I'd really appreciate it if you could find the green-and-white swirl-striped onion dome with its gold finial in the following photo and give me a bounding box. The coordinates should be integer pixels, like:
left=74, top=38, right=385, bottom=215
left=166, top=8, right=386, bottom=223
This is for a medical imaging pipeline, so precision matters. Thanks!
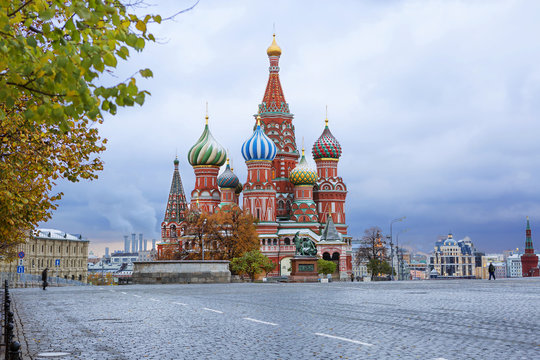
left=188, top=115, right=227, bottom=166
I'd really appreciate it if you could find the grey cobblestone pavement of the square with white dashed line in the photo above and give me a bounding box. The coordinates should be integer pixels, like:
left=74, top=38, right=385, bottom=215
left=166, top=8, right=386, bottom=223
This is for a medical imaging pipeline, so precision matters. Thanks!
left=12, top=279, right=540, bottom=360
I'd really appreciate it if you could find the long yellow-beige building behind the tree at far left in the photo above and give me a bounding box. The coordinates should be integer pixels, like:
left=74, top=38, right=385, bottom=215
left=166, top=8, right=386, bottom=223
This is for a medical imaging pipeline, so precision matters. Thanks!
left=0, top=229, right=89, bottom=282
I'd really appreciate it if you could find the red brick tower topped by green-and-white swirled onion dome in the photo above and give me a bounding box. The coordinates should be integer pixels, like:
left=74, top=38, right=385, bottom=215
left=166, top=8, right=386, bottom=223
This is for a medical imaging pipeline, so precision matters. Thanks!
left=188, top=114, right=227, bottom=213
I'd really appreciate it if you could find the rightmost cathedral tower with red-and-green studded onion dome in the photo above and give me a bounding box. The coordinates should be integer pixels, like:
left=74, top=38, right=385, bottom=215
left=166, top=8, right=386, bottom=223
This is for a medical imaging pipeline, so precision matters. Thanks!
left=312, top=115, right=347, bottom=234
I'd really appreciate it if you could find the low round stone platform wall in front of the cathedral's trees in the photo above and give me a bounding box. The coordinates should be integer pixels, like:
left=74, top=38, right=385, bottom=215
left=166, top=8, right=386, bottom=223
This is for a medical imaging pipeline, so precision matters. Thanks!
left=132, top=260, right=231, bottom=284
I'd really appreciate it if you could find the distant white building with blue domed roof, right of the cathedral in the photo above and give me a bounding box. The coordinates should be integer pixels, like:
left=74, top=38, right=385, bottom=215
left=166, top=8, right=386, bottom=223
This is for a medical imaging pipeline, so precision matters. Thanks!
left=430, top=234, right=475, bottom=278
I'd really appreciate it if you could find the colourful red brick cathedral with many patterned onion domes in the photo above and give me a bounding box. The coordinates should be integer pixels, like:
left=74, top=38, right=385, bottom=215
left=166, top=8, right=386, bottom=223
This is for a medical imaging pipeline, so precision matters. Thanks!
left=158, top=35, right=352, bottom=279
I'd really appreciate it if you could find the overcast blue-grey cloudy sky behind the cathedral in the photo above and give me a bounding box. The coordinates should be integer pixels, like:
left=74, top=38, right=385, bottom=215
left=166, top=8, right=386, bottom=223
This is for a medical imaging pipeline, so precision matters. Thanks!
left=42, top=0, right=540, bottom=253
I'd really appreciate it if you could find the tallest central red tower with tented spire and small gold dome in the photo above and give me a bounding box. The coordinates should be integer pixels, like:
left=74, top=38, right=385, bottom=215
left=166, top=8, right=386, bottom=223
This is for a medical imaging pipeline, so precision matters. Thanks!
left=258, top=34, right=299, bottom=219
